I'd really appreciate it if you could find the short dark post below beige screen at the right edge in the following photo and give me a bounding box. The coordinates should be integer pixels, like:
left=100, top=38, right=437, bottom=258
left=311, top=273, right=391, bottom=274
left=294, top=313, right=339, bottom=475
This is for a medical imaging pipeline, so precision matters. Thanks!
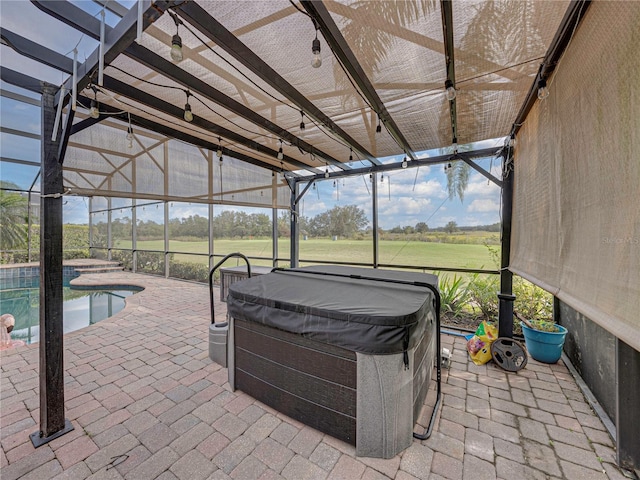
left=616, top=339, right=640, bottom=473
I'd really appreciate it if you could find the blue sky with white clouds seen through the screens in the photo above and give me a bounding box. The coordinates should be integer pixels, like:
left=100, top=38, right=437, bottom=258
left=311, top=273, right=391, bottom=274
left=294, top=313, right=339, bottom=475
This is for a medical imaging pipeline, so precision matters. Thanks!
left=0, top=0, right=502, bottom=229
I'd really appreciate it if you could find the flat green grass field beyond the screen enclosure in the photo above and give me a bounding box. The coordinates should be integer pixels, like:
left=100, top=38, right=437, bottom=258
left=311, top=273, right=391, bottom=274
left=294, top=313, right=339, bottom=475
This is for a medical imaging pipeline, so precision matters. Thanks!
left=116, top=239, right=497, bottom=270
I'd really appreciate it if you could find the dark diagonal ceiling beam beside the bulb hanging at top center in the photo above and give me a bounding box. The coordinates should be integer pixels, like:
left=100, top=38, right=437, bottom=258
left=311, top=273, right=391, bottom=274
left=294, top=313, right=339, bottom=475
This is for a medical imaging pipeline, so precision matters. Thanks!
left=300, top=0, right=416, bottom=165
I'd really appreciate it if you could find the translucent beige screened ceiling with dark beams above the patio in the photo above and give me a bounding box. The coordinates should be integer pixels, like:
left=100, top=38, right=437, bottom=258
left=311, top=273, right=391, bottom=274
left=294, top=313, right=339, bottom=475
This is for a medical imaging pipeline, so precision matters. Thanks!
left=2, top=0, right=581, bottom=200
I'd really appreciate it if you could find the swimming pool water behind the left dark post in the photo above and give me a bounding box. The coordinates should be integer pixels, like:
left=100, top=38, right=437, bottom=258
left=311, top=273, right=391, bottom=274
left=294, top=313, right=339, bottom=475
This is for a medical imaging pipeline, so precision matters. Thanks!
left=0, top=277, right=140, bottom=343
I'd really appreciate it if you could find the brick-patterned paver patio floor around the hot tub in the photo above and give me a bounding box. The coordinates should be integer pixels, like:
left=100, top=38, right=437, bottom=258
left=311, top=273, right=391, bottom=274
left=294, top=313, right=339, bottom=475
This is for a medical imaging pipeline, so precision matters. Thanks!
left=0, top=272, right=625, bottom=480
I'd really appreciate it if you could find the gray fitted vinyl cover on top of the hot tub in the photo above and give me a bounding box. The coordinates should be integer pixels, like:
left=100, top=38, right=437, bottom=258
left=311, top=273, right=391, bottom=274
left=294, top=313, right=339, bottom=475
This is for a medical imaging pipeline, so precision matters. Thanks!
left=227, top=266, right=437, bottom=355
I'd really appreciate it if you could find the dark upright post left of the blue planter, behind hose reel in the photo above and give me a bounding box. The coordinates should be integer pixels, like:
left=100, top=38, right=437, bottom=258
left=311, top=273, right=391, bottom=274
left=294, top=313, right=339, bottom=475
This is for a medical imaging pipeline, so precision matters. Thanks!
left=498, top=148, right=516, bottom=338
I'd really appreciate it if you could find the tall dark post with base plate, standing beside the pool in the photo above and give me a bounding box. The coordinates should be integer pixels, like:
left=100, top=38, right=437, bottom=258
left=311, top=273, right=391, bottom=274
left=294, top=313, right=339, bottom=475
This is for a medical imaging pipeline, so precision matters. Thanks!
left=30, top=84, right=73, bottom=447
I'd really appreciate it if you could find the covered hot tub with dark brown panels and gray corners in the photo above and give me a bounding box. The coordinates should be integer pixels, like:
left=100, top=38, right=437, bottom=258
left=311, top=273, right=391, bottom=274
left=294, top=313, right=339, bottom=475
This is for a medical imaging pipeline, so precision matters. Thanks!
left=227, top=266, right=438, bottom=458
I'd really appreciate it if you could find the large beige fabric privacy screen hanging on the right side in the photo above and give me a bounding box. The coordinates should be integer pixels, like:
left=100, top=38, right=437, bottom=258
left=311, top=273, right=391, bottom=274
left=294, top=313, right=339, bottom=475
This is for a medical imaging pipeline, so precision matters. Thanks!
left=511, top=2, right=640, bottom=350
